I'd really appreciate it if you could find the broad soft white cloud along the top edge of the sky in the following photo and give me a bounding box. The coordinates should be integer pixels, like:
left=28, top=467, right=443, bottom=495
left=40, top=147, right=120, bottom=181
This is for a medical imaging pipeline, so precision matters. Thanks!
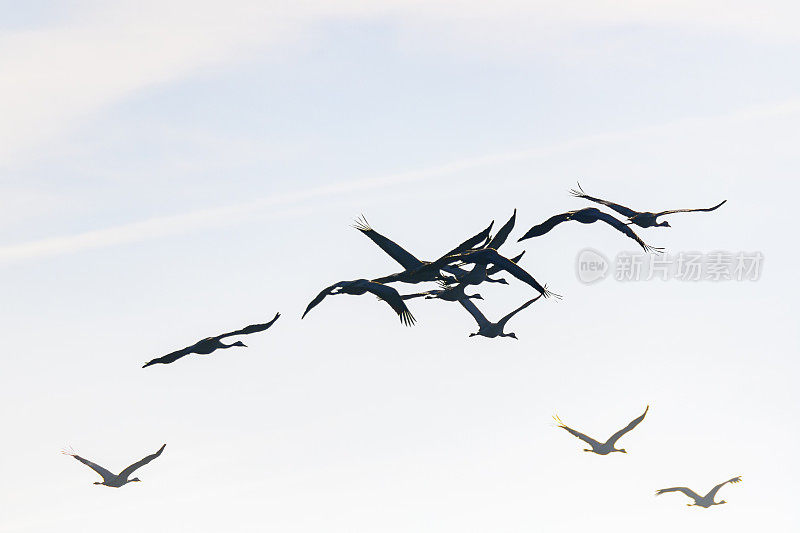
left=0, top=0, right=800, bottom=163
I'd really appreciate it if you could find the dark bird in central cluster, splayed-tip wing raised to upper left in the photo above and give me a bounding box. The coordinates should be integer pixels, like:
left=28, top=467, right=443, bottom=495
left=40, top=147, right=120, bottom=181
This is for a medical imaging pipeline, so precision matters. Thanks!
left=353, top=215, right=494, bottom=283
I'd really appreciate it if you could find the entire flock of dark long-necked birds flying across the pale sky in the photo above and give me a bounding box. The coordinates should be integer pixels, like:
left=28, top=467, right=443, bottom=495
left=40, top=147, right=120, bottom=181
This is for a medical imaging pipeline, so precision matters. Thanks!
left=62, top=184, right=741, bottom=508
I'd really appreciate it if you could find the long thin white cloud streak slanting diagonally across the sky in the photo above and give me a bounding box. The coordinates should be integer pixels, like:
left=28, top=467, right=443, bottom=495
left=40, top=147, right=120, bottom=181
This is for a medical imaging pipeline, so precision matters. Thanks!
left=0, top=96, right=800, bottom=263
